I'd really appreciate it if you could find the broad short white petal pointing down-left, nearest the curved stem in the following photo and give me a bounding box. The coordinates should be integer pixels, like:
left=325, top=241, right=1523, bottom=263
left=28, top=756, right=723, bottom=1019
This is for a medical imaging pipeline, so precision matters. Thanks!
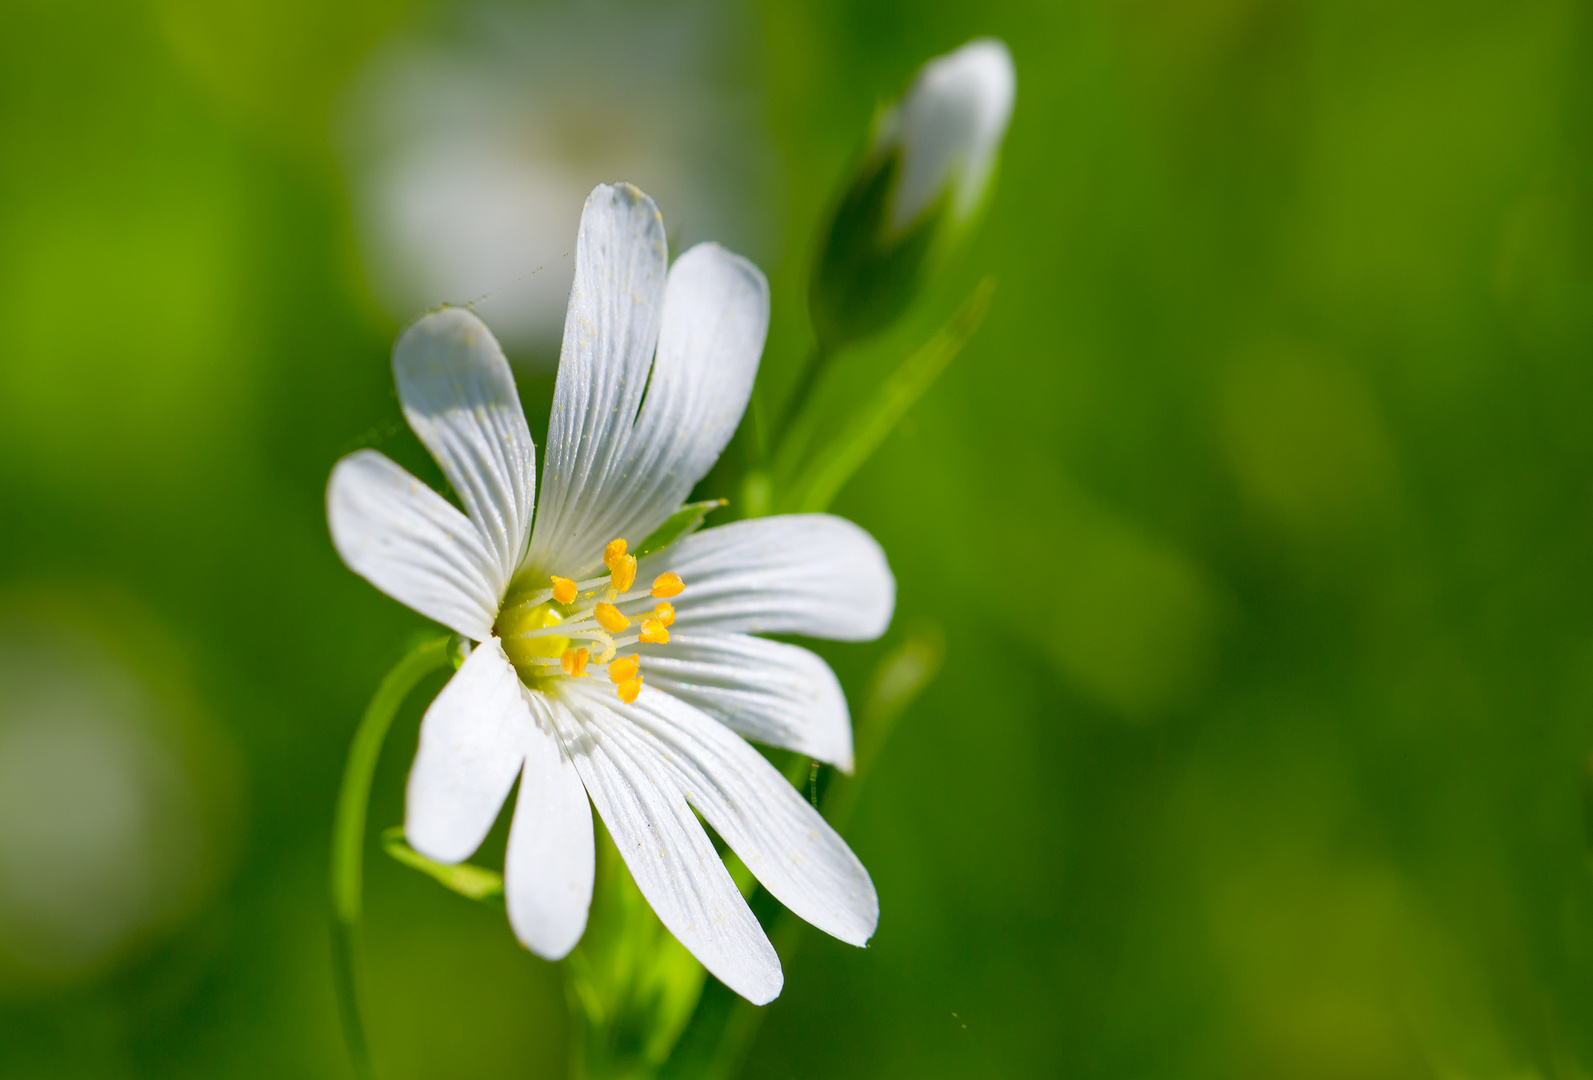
left=403, top=636, right=530, bottom=863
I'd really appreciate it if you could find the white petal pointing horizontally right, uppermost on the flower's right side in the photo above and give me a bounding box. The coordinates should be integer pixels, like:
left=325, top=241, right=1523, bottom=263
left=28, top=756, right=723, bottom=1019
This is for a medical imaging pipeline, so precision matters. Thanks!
left=640, top=515, right=895, bottom=642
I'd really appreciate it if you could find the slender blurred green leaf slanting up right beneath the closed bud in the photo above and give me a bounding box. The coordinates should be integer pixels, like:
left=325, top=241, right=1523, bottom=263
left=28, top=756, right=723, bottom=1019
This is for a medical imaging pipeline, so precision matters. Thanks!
left=777, top=277, right=996, bottom=513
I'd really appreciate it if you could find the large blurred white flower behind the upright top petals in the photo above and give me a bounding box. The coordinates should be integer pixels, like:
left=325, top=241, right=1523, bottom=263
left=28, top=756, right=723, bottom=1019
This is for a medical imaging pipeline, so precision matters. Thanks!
left=346, top=3, right=768, bottom=366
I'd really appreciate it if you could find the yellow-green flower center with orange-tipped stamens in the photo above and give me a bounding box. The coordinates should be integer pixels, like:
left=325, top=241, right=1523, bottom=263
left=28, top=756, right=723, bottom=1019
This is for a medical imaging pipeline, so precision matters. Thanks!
left=492, top=540, right=685, bottom=702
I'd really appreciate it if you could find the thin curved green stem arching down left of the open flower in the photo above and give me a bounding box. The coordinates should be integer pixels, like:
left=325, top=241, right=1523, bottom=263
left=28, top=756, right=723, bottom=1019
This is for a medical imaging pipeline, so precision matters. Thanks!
left=331, top=637, right=449, bottom=1080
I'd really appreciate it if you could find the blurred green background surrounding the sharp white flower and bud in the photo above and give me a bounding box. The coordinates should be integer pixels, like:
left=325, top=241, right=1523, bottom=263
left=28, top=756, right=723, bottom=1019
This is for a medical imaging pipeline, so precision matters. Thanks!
left=0, top=0, right=1593, bottom=1080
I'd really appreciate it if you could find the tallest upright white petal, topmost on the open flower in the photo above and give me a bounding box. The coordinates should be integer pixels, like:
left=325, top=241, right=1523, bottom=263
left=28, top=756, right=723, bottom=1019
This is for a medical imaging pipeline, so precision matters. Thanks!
left=527, top=183, right=669, bottom=573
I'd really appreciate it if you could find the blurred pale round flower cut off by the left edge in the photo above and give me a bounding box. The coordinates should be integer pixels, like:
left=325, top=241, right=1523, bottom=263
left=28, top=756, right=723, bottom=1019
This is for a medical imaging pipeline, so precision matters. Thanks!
left=0, top=608, right=221, bottom=978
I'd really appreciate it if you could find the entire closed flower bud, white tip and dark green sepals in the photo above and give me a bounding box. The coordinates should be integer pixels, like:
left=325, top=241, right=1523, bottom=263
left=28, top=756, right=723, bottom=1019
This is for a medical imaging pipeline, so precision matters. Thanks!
left=809, top=38, right=1016, bottom=347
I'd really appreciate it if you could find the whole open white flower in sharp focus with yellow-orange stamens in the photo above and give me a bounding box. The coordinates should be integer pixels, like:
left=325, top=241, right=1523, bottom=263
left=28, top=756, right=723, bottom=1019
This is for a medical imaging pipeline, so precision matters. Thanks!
left=327, top=185, right=895, bottom=1004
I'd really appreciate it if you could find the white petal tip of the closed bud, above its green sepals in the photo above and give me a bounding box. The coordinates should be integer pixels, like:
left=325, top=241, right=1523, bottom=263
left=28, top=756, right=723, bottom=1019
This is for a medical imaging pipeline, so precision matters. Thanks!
left=875, top=38, right=1018, bottom=231
